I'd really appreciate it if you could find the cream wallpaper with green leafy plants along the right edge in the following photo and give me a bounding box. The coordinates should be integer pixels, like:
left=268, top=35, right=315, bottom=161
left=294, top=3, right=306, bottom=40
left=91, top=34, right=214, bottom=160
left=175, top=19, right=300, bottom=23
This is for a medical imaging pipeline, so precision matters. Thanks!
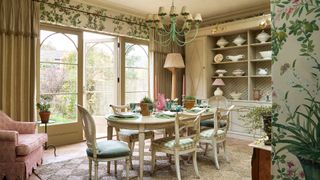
left=271, top=0, right=320, bottom=180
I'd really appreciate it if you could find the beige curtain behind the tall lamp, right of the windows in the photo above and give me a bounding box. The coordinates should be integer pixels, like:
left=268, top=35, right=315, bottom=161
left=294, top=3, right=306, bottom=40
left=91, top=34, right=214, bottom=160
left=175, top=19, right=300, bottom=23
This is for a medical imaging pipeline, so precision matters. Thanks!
left=150, top=34, right=185, bottom=101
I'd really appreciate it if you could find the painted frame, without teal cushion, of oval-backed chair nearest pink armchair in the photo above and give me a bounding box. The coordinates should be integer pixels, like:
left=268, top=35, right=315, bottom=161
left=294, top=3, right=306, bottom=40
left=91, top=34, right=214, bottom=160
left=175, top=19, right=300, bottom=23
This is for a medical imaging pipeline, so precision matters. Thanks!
left=77, top=105, right=129, bottom=180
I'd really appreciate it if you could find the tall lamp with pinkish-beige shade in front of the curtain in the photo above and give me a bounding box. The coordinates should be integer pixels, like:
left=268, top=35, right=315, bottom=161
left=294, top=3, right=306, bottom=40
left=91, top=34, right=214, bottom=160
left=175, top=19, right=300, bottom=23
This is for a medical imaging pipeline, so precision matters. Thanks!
left=163, top=53, right=185, bottom=99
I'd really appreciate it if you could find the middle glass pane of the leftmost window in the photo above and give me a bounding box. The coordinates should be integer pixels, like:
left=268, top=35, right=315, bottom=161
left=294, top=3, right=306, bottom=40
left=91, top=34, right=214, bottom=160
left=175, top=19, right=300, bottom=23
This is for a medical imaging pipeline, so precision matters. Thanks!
left=40, top=63, right=77, bottom=94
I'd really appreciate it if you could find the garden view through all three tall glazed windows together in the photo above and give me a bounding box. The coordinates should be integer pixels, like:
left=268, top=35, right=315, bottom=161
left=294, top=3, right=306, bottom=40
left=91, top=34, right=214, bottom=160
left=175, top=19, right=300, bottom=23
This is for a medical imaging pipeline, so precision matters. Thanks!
left=39, top=30, right=150, bottom=131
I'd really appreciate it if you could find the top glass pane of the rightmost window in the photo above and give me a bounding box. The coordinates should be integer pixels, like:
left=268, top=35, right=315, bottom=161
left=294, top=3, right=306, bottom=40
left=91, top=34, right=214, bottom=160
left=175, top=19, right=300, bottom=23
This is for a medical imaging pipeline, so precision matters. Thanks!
left=126, top=43, right=148, bottom=68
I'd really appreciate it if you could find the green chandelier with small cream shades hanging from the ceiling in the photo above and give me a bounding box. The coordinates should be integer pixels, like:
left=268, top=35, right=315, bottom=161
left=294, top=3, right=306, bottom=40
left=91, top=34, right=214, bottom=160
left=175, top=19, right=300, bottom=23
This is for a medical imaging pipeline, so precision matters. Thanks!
left=146, top=0, right=202, bottom=46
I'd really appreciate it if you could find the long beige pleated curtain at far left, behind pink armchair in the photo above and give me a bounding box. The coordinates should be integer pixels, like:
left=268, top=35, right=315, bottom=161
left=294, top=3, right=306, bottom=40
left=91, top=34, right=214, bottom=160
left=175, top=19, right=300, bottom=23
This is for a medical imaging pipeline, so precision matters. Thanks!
left=0, top=0, right=39, bottom=121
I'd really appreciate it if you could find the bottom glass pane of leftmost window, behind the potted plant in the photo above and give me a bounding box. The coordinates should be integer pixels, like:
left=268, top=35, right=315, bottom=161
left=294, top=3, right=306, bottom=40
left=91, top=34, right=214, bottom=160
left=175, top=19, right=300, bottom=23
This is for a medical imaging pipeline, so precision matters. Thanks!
left=40, top=94, right=77, bottom=123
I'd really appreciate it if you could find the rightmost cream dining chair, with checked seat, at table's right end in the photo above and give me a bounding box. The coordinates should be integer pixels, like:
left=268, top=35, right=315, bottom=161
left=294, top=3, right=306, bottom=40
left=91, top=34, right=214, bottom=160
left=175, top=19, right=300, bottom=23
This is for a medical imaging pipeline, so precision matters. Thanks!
left=199, top=105, right=235, bottom=169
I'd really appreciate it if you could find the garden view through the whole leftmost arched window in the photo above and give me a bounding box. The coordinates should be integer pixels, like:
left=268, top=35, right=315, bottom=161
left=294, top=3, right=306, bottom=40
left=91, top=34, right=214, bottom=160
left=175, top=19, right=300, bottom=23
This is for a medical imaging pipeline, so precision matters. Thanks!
left=39, top=30, right=78, bottom=123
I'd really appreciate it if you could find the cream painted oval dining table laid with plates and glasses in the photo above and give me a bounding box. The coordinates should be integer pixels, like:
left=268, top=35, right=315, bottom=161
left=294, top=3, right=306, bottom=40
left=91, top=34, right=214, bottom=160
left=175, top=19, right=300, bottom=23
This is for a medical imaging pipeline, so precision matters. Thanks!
left=106, top=111, right=214, bottom=179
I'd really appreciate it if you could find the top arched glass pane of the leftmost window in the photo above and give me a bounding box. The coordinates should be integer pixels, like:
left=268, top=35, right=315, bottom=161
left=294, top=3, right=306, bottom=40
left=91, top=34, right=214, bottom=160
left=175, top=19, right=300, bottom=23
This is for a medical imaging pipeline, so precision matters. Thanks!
left=40, top=31, right=78, bottom=63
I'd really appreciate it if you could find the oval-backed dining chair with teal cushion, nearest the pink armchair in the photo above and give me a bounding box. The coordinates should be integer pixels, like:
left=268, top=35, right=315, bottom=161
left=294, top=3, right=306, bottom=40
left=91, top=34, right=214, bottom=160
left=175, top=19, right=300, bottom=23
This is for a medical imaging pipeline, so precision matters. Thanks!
left=77, top=105, right=130, bottom=180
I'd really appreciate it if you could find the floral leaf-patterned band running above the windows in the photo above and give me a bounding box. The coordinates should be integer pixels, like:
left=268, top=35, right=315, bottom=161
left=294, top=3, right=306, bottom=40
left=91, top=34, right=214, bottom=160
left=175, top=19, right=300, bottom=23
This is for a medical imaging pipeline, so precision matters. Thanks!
left=39, top=0, right=149, bottom=39
